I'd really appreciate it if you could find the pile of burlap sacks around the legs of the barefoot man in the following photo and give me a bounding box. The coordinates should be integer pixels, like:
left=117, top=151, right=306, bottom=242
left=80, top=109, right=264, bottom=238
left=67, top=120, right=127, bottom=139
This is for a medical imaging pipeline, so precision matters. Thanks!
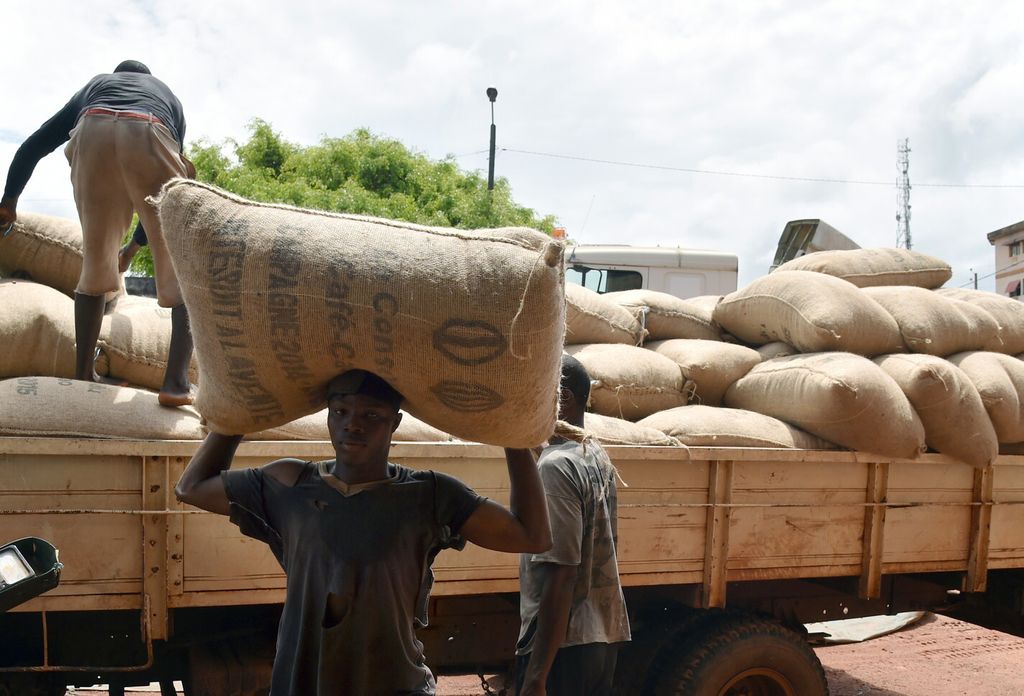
left=0, top=213, right=203, bottom=439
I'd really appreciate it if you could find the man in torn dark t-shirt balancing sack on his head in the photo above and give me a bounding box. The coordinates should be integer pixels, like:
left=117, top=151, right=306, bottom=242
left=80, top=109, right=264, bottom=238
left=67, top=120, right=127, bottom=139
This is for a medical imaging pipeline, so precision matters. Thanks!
left=175, top=369, right=551, bottom=696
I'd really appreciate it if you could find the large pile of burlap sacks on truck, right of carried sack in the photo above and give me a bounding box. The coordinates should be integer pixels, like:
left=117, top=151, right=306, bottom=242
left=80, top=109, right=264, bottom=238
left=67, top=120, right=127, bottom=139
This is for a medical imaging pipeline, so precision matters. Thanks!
left=565, top=249, right=1024, bottom=467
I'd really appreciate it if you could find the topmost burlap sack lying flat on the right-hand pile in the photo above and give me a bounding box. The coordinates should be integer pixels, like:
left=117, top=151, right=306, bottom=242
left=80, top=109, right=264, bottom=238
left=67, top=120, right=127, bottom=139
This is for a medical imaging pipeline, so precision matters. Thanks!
left=775, top=249, right=952, bottom=289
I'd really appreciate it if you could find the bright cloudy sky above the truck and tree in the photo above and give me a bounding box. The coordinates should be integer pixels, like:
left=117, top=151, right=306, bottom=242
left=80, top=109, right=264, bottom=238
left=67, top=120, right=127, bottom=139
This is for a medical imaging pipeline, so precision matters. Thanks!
left=6, top=0, right=1024, bottom=290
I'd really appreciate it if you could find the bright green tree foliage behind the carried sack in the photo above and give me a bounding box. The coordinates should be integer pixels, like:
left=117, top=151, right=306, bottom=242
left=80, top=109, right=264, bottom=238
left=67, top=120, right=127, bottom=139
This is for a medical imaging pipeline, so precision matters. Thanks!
left=132, top=119, right=555, bottom=273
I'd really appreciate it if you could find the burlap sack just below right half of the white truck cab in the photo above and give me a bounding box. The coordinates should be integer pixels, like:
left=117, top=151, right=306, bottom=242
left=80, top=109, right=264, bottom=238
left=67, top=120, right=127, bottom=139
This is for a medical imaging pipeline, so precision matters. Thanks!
left=603, top=290, right=721, bottom=341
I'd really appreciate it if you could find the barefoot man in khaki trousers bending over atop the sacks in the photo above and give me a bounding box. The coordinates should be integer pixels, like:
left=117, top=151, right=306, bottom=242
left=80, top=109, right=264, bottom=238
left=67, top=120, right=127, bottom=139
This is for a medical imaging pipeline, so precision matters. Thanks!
left=0, top=60, right=196, bottom=406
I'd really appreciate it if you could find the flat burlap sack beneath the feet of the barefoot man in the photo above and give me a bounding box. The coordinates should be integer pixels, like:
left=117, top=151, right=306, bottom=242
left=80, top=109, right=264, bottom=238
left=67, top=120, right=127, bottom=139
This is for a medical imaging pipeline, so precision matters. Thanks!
left=0, top=377, right=206, bottom=440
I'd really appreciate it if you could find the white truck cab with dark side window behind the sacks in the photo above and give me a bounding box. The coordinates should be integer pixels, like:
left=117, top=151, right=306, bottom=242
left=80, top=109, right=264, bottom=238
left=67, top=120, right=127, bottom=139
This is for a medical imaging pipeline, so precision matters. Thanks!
left=565, top=245, right=739, bottom=299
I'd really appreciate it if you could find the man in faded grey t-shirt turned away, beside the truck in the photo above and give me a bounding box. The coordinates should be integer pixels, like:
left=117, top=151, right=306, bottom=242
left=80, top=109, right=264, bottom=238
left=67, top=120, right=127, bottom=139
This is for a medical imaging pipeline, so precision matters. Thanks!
left=516, top=355, right=630, bottom=696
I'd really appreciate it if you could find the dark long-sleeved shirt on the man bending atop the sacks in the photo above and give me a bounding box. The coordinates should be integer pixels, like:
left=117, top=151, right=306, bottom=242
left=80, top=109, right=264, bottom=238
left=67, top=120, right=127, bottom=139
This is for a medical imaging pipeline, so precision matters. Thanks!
left=4, top=73, right=185, bottom=198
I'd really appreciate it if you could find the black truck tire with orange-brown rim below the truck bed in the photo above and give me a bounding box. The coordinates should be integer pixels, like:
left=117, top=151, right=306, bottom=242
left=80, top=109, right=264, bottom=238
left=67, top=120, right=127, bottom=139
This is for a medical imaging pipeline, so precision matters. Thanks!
left=651, top=615, right=828, bottom=696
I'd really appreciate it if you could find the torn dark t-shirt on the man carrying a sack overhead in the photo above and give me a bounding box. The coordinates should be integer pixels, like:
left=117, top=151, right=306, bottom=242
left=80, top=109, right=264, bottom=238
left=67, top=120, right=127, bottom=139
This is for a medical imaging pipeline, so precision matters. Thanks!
left=221, top=463, right=484, bottom=696
